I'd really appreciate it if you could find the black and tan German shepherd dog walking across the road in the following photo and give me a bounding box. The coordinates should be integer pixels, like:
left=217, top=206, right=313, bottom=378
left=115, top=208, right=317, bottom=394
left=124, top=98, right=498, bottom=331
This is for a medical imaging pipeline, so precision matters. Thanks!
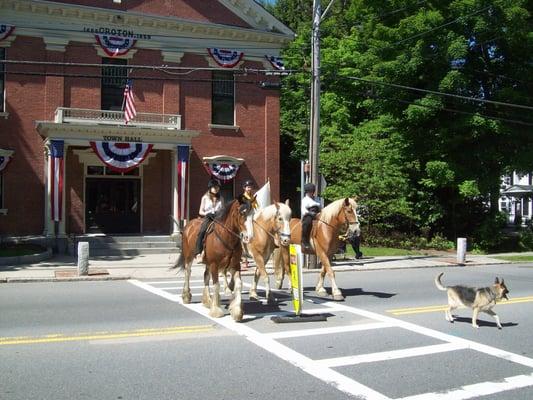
left=435, top=272, right=509, bottom=329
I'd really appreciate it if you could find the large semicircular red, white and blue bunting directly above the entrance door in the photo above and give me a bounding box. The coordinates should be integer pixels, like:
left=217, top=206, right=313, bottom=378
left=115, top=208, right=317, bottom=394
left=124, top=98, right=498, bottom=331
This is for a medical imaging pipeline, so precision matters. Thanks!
left=90, top=142, right=154, bottom=172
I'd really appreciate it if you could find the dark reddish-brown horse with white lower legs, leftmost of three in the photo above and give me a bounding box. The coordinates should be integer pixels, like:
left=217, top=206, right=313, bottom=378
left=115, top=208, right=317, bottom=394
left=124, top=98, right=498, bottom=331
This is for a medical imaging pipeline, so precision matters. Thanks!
left=175, top=198, right=254, bottom=321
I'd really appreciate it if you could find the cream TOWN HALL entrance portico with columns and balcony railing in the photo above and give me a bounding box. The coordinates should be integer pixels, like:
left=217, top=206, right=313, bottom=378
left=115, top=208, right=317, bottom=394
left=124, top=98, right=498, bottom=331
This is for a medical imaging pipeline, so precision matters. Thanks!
left=36, top=107, right=199, bottom=244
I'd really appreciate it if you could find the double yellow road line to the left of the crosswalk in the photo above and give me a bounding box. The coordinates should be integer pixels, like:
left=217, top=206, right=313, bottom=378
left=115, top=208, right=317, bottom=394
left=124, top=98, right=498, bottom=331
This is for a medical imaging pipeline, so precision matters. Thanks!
left=0, top=325, right=215, bottom=346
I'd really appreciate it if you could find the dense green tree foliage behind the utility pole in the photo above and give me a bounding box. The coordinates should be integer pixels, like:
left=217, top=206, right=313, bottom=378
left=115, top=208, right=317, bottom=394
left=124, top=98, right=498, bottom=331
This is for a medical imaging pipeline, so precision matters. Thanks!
left=273, top=0, right=533, bottom=248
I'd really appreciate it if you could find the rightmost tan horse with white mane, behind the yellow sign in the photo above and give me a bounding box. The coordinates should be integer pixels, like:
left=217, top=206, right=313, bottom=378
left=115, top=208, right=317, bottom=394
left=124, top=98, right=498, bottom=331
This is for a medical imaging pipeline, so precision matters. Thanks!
left=274, top=197, right=360, bottom=300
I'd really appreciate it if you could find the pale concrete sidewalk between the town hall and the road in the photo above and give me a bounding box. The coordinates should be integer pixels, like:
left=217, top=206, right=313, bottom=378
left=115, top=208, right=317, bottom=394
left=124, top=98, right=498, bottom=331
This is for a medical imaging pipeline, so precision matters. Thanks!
left=0, top=253, right=512, bottom=283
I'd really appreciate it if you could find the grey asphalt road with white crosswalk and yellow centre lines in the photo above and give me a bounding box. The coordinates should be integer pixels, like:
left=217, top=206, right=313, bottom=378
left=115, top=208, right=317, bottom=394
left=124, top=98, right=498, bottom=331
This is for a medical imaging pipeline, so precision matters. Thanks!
left=0, top=264, right=533, bottom=400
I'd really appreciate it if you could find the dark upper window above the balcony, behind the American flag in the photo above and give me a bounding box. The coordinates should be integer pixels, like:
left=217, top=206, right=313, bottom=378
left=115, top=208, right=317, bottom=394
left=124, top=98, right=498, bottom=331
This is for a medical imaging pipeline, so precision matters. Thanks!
left=101, top=58, right=128, bottom=111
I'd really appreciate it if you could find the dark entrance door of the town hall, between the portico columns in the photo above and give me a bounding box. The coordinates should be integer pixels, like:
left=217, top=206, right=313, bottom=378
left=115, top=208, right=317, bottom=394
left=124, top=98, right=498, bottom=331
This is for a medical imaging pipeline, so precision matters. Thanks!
left=85, top=178, right=141, bottom=233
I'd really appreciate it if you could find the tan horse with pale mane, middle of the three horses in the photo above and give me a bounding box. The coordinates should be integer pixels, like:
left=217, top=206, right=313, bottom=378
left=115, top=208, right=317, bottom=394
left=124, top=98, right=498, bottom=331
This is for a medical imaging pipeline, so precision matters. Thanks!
left=248, top=203, right=292, bottom=303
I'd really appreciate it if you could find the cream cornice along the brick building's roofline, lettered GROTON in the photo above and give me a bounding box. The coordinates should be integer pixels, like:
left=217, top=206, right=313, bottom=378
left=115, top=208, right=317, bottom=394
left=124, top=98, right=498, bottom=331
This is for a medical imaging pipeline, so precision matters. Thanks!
left=0, top=0, right=294, bottom=54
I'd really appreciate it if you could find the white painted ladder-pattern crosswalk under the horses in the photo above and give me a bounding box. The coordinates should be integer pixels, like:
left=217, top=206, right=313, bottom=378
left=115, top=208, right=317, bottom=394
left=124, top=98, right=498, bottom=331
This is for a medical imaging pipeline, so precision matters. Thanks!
left=130, top=280, right=533, bottom=400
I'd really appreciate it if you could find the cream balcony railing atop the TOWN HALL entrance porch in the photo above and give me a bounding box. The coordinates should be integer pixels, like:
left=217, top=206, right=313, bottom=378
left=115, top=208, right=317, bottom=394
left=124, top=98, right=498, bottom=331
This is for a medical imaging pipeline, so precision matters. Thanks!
left=55, top=107, right=181, bottom=129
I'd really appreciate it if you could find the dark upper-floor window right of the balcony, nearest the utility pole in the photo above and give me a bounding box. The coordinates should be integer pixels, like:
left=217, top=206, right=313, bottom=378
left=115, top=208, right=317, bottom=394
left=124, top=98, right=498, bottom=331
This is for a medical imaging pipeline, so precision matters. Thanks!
left=211, top=71, right=235, bottom=125
